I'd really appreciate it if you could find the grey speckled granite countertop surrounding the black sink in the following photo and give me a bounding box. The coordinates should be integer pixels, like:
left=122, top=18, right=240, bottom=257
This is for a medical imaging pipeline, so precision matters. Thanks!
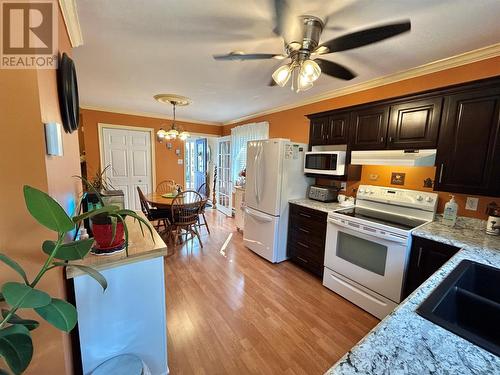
left=327, top=219, right=500, bottom=375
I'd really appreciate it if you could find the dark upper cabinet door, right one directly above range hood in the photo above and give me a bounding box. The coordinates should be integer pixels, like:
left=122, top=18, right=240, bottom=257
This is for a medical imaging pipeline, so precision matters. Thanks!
left=387, top=98, right=443, bottom=149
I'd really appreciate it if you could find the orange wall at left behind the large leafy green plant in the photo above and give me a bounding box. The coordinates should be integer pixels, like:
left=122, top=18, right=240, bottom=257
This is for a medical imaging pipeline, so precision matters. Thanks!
left=0, top=4, right=77, bottom=374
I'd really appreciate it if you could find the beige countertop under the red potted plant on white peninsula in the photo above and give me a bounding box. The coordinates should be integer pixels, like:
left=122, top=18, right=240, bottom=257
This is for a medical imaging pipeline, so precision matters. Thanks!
left=66, top=211, right=167, bottom=279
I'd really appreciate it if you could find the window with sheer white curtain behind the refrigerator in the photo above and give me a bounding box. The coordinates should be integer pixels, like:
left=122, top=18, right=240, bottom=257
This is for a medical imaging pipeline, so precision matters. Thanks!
left=231, top=122, right=269, bottom=183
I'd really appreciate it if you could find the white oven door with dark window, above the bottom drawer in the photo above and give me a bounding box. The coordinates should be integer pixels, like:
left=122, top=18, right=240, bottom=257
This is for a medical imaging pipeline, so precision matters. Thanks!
left=325, top=218, right=408, bottom=303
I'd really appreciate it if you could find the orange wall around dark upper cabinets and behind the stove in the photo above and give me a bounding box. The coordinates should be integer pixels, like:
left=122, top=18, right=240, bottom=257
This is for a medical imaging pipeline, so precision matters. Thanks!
left=223, top=57, right=500, bottom=218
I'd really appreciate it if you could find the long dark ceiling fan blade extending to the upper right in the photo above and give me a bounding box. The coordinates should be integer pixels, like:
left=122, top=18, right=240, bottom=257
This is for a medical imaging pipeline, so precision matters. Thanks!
left=318, top=20, right=411, bottom=54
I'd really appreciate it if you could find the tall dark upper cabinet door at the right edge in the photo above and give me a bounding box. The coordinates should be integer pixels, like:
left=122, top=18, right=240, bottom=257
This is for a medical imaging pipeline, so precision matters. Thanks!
left=435, top=88, right=500, bottom=196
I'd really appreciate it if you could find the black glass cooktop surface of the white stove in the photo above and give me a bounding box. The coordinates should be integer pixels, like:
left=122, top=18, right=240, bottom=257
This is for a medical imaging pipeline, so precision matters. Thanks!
left=335, top=207, right=427, bottom=230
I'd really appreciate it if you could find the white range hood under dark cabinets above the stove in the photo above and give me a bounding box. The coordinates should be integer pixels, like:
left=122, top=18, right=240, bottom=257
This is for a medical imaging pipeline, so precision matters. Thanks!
left=351, top=149, right=436, bottom=167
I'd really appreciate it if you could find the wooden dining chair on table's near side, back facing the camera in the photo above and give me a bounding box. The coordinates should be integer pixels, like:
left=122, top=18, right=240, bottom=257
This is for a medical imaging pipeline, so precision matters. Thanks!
left=170, top=190, right=203, bottom=248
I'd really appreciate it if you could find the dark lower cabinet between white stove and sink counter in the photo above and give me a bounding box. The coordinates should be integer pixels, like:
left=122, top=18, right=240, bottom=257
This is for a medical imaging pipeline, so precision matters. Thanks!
left=403, top=237, right=459, bottom=298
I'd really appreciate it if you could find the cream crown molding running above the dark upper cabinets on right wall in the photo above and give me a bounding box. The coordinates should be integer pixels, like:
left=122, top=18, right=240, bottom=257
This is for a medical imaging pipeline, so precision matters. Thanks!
left=223, top=43, right=500, bottom=125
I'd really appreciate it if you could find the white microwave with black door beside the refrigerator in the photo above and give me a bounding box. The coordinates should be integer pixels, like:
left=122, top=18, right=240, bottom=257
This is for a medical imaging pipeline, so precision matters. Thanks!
left=304, top=151, right=346, bottom=176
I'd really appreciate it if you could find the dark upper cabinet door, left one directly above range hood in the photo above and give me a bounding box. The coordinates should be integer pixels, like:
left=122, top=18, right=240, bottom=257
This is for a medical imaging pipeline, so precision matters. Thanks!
left=351, top=106, right=389, bottom=150
